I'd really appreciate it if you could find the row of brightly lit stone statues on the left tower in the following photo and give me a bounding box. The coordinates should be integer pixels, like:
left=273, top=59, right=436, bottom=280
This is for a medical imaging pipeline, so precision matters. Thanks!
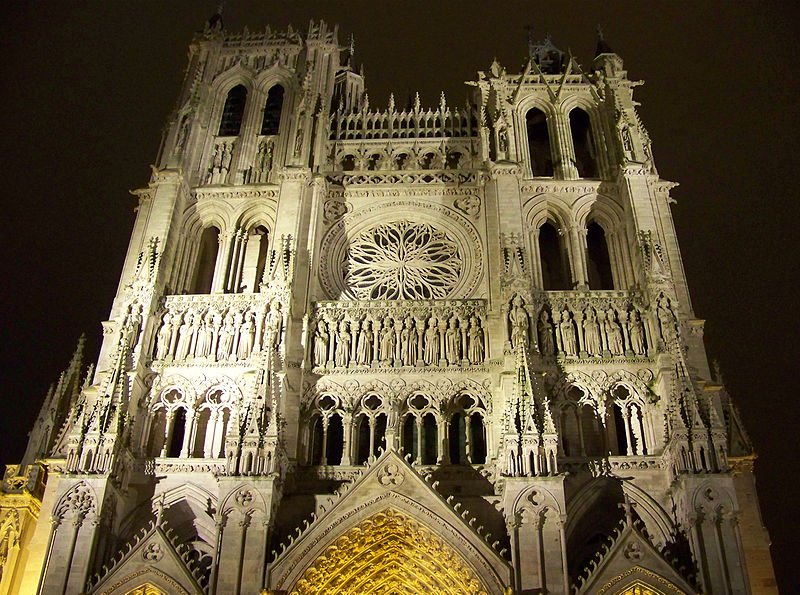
left=154, top=301, right=283, bottom=362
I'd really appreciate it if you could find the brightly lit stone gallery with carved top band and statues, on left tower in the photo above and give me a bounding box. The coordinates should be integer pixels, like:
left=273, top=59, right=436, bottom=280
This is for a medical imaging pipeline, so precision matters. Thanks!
left=153, top=293, right=283, bottom=364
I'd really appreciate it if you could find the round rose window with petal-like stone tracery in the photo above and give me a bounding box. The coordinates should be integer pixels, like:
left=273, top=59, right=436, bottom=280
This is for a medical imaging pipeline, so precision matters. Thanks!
left=341, top=221, right=464, bottom=300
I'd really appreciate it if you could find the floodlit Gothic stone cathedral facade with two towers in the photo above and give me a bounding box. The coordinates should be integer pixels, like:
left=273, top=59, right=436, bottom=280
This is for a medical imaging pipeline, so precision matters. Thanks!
left=0, top=15, right=777, bottom=595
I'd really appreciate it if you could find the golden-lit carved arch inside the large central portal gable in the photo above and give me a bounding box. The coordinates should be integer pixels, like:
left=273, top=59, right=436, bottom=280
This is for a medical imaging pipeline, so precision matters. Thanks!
left=291, top=509, right=488, bottom=595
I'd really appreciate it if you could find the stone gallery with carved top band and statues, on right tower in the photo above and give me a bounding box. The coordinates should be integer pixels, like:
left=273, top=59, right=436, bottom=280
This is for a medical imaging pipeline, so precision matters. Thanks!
left=528, top=291, right=656, bottom=358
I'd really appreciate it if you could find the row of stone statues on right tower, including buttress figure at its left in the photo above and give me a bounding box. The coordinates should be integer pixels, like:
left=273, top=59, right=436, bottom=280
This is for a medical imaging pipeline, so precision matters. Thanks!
left=508, top=296, right=652, bottom=357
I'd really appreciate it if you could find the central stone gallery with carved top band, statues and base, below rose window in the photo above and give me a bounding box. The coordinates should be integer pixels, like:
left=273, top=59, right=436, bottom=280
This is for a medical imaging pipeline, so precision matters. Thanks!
left=311, top=300, right=487, bottom=372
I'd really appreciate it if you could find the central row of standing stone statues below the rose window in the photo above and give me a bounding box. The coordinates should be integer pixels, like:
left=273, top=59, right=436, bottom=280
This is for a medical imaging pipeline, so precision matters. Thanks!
left=313, top=313, right=486, bottom=368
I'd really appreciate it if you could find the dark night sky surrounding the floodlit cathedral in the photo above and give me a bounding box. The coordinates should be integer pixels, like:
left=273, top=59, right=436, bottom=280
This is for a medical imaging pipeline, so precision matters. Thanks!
left=0, top=0, right=800, bottom=593
